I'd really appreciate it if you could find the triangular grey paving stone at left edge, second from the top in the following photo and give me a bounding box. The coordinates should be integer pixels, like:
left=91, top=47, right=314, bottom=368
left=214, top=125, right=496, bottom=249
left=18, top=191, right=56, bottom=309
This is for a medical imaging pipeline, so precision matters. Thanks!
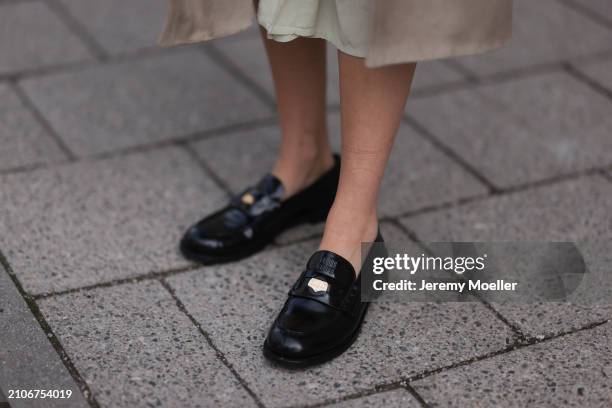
left=0, top=84, right=66, bottom=170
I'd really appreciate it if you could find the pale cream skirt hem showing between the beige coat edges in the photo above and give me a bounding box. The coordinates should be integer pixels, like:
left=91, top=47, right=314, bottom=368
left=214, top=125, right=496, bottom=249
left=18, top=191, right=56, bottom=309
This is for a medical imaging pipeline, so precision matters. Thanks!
left=257, top=0, right=374, bottom=57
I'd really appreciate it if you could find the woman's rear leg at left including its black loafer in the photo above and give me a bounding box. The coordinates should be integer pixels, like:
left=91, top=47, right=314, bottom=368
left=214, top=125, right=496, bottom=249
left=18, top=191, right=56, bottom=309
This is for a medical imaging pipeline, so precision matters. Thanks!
left=180, top=33, right=340, bottom=265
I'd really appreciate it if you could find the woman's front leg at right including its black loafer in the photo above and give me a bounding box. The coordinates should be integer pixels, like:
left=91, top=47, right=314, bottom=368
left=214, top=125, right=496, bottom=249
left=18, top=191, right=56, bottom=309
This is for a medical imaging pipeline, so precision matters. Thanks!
left=263, top=48, right=415, bottom=367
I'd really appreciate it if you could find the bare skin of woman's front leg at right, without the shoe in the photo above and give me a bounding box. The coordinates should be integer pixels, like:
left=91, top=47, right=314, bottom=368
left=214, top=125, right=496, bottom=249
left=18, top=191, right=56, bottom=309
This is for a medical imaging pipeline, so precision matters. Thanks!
left=320, top=52, right=416, bottom=272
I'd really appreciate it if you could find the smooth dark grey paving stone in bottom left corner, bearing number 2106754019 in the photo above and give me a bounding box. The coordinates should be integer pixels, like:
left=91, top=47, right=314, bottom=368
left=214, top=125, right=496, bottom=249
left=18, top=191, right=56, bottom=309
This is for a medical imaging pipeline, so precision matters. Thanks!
left=0, top=265, right=89, bottom=408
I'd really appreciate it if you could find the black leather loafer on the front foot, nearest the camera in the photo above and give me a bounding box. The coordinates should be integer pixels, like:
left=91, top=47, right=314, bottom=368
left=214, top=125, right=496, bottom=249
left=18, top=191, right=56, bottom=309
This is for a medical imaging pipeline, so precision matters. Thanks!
left=263, top=232, right=386, bottom=368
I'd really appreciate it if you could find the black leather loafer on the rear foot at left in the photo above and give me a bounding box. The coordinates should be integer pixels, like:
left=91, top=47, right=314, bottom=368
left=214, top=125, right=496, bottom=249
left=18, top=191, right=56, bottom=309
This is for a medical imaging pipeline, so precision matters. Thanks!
left=180, top=155, right=340, bottom=265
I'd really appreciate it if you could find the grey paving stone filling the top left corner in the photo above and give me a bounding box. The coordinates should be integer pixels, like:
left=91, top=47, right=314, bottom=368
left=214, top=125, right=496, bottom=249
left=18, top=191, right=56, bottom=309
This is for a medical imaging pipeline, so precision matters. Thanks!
left=0, top=1, right=91, bottom=74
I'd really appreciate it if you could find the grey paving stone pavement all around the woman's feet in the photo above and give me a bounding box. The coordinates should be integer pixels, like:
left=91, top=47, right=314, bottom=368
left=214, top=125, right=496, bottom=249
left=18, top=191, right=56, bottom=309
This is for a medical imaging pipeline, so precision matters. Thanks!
left=0, top=0, right=612, bottom=407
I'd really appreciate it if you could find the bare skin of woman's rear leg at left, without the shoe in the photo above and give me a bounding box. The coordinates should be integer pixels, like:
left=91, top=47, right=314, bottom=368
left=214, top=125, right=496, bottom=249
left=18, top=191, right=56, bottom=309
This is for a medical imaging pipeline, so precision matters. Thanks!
left=261, top=28, right=334, bottom=198
